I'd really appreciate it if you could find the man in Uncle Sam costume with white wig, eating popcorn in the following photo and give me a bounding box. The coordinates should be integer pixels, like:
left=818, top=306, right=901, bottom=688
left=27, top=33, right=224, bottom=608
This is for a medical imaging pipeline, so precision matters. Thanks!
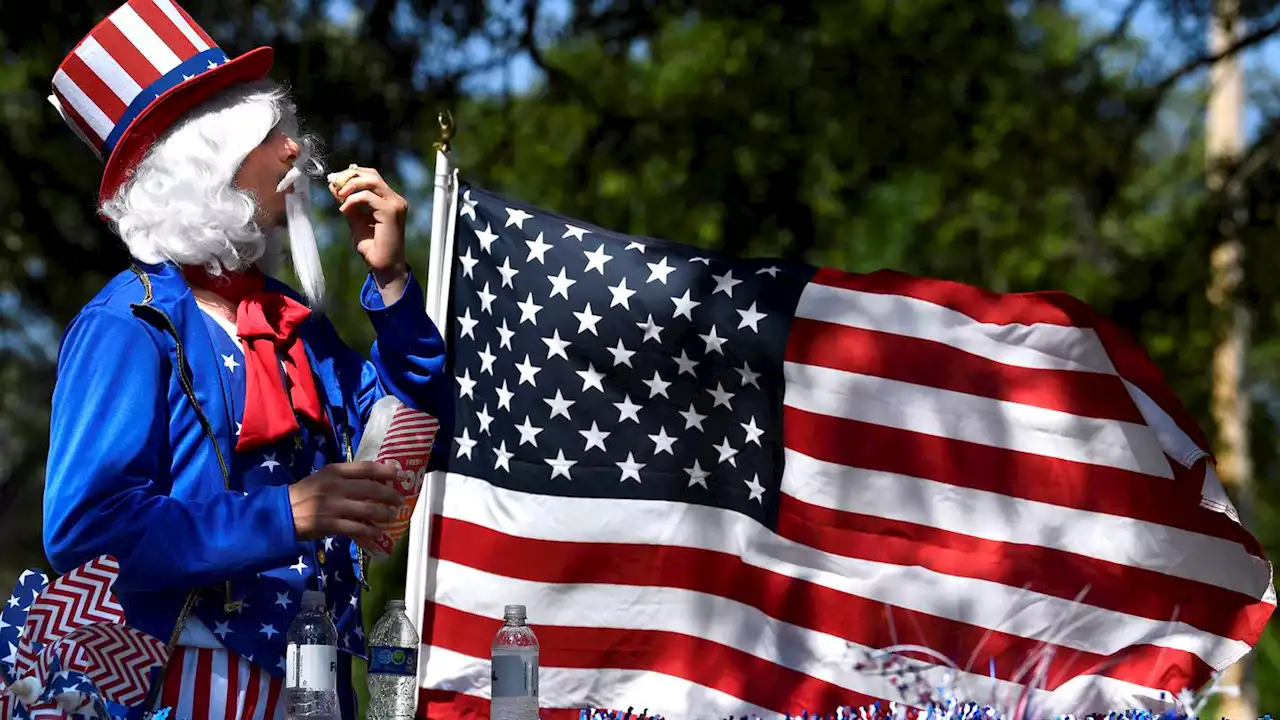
left=45, top=0, right=448, bottom=720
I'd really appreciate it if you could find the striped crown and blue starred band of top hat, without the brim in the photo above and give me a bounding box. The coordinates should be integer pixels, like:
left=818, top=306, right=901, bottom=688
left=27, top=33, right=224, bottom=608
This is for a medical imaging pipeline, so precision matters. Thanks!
left=49, top=0, right=227, bottom=159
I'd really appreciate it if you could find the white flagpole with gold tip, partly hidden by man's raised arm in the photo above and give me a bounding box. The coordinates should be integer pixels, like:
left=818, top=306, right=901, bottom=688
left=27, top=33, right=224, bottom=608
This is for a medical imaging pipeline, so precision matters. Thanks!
left=404, top=110, right=458, bottom=691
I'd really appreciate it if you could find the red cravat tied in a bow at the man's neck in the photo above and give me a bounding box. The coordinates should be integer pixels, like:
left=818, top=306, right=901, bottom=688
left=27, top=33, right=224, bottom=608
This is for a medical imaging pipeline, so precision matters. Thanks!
left=183, top=268, right=325, bottom=452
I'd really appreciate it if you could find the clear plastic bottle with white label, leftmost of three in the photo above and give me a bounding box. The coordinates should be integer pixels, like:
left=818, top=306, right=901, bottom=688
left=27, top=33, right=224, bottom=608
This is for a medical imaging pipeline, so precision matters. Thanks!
left=284, top=591, right=339, bottom=720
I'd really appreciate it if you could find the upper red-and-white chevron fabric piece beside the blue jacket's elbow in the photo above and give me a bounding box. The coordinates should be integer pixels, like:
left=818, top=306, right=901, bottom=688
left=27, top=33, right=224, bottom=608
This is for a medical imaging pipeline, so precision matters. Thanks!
left=17, top=555, right=124, bottom=678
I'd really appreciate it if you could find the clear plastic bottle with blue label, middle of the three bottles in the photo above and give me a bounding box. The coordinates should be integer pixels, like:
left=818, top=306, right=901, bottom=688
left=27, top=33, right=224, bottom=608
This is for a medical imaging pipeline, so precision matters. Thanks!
left=367, top=600, right=419, bottom=720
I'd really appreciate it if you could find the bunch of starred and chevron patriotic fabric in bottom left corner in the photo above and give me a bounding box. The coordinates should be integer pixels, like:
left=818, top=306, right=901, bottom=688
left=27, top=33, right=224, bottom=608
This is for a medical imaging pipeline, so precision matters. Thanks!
left=0, top=555, right=168, bottom=720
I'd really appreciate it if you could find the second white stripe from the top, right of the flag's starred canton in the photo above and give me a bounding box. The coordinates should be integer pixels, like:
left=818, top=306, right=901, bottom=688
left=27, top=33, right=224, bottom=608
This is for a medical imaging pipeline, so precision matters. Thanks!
left=783, top=363, right=1174, bottom=479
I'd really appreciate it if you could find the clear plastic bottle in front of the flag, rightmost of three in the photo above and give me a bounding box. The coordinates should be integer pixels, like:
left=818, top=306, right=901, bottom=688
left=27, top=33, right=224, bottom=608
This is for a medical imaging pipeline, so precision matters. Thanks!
left=489, top=605, right=538, bottom=720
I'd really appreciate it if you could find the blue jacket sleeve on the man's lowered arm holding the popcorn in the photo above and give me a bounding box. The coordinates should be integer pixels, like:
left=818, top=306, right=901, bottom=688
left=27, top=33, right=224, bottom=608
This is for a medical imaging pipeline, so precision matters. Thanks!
left=44, top=306, right=297, bottom=591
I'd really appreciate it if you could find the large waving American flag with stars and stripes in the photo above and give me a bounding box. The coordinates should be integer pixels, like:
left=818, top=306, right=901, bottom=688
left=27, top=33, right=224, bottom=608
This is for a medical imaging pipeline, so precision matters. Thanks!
left=419, top=186, right=1275, bottom=717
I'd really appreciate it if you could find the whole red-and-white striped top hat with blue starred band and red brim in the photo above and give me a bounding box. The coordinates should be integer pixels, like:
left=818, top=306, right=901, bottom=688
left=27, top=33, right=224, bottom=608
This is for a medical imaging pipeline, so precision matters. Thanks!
left=49, top=0, right=274, bottom=202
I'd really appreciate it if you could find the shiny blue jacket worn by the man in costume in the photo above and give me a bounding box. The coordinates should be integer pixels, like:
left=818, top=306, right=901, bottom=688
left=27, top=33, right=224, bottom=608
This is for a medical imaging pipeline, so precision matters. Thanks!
left=44, top=264, right=451, bottom=655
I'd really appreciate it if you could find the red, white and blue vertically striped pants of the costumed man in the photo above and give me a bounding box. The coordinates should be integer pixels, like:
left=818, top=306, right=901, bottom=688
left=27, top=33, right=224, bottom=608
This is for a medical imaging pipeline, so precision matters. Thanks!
left=160, top=647, right=284, bottom=720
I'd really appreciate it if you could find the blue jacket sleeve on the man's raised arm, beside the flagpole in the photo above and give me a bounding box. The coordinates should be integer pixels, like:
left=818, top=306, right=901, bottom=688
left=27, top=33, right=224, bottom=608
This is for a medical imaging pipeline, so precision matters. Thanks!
left=358, top=270, right=453, bottom=421
